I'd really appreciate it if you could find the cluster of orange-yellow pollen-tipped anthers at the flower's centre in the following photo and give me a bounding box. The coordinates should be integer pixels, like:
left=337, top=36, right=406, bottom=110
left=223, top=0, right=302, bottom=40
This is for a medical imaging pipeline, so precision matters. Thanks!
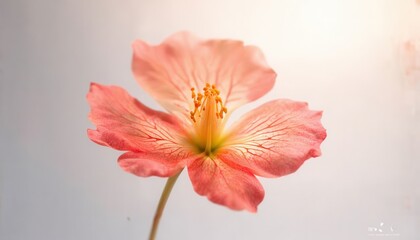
left=190, top=83, right=227, bottom=122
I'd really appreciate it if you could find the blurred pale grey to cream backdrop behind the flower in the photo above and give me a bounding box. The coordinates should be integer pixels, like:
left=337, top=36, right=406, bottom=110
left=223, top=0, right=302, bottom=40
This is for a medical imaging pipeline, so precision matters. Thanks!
left=0, top=0, right=420, bottom=240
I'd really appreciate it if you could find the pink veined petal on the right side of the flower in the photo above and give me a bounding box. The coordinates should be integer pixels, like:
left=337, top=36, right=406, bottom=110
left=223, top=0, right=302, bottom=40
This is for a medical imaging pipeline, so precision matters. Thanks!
left=218, top=99, right=326, bottom=177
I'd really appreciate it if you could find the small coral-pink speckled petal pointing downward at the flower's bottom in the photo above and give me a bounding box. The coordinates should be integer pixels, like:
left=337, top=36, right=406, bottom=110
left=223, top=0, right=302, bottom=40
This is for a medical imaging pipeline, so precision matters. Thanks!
left=188, top=157, right=264, bottom=212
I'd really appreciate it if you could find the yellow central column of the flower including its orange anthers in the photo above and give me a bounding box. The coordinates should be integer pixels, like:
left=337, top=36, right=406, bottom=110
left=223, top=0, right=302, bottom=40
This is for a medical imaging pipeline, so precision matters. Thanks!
left=190, top=83, right=227, bottom=155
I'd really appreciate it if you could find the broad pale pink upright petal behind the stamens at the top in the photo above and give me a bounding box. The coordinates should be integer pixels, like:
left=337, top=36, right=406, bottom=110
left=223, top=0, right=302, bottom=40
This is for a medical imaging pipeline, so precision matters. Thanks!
left=132, top=32, right=276, bottom=119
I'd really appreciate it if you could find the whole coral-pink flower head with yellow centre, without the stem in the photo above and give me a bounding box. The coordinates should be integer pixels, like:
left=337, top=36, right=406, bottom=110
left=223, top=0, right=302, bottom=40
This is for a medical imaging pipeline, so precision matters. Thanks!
left=87, top=32, right=326, bottom=212
